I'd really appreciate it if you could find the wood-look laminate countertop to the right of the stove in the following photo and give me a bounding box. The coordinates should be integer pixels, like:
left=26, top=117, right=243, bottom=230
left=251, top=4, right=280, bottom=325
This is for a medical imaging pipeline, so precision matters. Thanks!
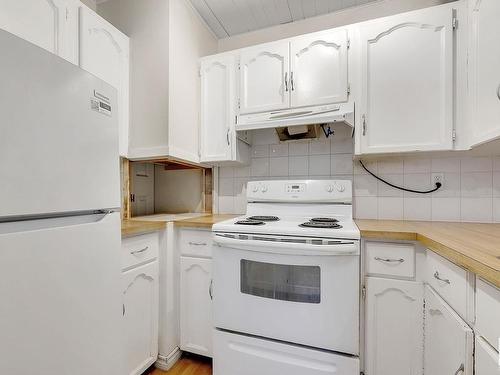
left=356, top=220, right=500, bottom=288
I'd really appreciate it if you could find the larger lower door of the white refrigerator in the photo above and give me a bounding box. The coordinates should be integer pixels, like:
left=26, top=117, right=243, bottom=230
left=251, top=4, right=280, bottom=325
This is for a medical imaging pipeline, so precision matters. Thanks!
left=0, top=213, right=124, bottom=375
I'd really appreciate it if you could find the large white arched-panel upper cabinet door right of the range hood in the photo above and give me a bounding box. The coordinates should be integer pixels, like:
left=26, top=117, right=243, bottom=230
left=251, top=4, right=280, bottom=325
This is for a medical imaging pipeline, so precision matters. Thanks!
left=358, top=5, right=454, bottom=154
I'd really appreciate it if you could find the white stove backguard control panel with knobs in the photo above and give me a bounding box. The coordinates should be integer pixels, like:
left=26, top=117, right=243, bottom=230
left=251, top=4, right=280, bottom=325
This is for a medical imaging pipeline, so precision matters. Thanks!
left=247, top=180, right=352, bottom=204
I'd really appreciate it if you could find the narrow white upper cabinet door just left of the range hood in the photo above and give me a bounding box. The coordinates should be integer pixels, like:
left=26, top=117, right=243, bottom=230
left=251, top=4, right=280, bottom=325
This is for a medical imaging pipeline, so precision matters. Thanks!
left=200, top=55, right=236, bottom=162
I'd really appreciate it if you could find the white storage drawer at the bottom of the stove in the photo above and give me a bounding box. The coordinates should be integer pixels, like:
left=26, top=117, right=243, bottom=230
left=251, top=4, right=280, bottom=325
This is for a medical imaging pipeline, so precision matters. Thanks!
left=214, top=330, right=359, bottom=375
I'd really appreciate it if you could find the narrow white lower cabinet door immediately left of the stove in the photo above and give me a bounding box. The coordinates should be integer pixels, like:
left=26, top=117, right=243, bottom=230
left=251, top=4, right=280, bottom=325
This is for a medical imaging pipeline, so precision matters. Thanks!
left=180, top=256, right=213, bottom=357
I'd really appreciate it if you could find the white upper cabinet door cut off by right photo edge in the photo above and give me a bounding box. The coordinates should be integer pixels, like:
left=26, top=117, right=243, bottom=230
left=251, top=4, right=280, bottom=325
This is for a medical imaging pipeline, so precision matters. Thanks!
left=469, top=0, right=500, bottom=146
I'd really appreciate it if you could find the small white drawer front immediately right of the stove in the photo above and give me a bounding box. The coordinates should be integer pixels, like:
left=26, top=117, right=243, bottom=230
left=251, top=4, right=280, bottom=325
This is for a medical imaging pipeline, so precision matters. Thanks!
left=365, top=242, right=415, bottom=278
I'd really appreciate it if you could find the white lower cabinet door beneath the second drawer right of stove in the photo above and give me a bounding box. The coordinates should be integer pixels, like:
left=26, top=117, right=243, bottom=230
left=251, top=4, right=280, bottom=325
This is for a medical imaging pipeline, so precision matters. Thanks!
left=424, top=286, right=470, bottom=375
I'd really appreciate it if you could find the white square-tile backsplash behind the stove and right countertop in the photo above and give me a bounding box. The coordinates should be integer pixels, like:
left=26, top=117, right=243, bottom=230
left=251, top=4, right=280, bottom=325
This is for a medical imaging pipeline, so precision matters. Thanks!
left=219, top=125, right=500, bottom=222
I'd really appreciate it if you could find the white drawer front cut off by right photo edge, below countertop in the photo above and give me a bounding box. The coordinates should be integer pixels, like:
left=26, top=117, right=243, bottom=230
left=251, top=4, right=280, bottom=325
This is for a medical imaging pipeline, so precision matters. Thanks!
left=476, top=278, right=500, bottom=347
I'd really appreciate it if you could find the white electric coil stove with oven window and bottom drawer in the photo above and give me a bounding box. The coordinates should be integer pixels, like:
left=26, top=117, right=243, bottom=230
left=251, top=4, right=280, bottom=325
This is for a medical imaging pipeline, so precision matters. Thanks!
left=213, top=180, right=360, bottom=375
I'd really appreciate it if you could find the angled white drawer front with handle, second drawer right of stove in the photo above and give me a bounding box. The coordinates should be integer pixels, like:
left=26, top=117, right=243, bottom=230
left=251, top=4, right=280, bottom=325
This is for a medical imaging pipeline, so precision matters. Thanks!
left=425, top=250, right=468, bottom=319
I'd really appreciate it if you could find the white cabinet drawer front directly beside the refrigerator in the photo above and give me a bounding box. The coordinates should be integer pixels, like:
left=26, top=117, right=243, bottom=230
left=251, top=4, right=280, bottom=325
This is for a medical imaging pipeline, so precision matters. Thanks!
left=122, top=233, right=159, bottom=269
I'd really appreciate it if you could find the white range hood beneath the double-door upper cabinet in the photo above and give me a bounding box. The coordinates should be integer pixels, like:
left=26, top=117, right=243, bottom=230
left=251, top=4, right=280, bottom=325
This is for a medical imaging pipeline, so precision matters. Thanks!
left=236, top=103, right=354, bottom=131
